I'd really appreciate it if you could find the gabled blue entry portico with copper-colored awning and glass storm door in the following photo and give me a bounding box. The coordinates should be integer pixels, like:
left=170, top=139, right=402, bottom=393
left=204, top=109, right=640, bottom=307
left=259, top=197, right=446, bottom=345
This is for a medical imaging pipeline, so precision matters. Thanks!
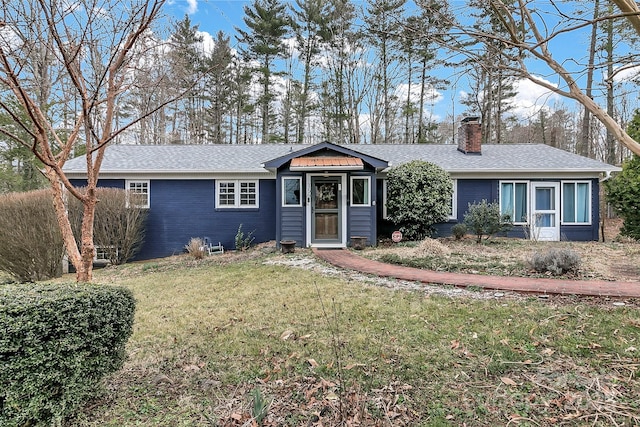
left=264, top=142, right=389, bottom=248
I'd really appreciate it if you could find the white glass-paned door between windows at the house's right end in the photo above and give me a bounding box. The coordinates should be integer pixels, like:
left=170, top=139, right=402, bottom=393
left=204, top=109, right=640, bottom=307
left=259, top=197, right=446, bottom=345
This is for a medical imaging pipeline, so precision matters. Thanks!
left=530, top=182, right=560, bottom=241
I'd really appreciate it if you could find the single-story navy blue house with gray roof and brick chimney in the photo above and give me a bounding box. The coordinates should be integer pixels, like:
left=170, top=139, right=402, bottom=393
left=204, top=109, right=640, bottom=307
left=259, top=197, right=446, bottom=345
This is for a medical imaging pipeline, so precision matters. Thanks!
left=64, top=119, right=620, bottom=259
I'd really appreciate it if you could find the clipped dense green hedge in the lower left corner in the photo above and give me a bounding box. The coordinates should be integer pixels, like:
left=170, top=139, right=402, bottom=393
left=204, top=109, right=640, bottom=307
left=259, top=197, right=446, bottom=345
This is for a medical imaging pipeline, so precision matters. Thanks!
left=0, top=284, right=135, bottom=426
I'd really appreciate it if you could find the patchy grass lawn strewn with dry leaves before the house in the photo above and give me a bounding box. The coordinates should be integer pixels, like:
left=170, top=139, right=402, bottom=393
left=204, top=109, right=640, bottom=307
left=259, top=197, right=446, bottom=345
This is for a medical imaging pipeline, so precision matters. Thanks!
left=72, top=250, right=640, bottom=426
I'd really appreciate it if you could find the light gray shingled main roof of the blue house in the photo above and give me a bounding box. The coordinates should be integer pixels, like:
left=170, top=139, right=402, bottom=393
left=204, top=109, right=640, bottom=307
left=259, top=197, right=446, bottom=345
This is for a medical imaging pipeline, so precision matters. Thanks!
left=64, top=144, right=620, bottom=177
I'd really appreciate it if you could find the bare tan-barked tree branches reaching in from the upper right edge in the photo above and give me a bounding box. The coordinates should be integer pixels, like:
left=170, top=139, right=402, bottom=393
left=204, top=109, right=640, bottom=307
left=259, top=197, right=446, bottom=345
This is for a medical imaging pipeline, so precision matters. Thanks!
left=430, top=0, right=640, bottom=154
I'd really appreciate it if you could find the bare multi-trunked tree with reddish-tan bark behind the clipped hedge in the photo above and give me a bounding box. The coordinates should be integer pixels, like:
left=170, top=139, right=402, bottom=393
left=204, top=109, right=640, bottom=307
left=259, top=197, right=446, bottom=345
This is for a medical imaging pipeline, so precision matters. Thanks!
left=0, top=0, right=170, bottom=282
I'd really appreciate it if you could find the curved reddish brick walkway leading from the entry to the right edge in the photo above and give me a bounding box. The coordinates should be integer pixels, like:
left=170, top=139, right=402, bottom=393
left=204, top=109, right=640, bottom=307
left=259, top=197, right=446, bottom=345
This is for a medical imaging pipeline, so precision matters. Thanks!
left=313, top=248, right=640, bottom=298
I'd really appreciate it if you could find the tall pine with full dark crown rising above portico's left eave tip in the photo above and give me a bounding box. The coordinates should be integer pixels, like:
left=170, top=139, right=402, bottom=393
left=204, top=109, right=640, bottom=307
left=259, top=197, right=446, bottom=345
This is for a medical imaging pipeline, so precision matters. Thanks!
left=236, top=0, right=291, bottom=144
